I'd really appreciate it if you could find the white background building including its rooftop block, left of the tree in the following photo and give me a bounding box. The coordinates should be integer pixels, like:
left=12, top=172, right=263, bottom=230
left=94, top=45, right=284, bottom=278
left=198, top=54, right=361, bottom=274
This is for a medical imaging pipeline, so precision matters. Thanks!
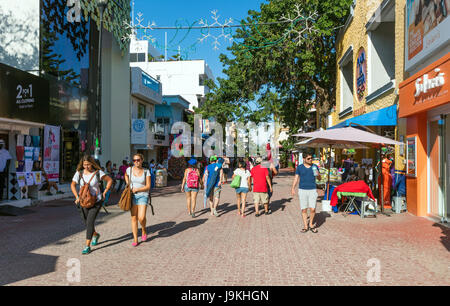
left=130, top=41, right=214, bottom=110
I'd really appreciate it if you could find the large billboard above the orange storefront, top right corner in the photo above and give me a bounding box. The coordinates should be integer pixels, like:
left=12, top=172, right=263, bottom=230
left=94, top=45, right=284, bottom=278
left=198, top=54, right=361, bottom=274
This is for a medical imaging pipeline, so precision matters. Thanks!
left=405, top=0, right=450, bottom=70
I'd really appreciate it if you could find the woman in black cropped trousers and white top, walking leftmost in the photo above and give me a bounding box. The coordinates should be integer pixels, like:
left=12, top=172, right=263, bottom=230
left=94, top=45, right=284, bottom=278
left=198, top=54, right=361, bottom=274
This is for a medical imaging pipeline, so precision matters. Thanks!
left=70, top=155, right=112, bottom=255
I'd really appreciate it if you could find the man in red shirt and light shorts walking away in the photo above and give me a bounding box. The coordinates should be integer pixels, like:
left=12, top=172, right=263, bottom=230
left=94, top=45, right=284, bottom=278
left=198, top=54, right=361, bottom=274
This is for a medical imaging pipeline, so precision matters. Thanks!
left=250, top=157, right=273, bottom=217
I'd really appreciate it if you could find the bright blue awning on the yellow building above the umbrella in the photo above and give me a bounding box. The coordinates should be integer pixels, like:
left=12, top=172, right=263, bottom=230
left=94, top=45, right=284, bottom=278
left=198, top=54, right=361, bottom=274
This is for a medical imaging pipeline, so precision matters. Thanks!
left=329, top=104, right=397, bottom=129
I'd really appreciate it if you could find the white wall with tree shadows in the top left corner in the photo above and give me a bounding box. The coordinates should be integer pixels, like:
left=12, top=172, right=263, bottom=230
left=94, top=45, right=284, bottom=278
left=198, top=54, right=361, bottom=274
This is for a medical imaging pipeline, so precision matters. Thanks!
left=0, top=0, right=40, bottom=71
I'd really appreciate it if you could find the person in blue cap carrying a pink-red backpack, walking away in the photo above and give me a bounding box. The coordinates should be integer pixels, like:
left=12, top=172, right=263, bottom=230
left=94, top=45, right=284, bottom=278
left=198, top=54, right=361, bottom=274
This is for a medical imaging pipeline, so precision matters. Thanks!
left=181, top=158, right=203, bottom=218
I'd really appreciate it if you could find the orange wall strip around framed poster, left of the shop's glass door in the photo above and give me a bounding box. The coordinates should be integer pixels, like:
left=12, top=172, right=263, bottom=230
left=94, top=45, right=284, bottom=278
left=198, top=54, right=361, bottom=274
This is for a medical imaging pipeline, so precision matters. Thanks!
left=406, top=112, right=428, bottom=217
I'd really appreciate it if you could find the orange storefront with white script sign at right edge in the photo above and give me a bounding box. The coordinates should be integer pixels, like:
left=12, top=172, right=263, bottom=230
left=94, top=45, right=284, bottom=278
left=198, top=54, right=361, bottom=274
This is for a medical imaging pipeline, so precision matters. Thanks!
left=399, top=53, right=450, bottom=221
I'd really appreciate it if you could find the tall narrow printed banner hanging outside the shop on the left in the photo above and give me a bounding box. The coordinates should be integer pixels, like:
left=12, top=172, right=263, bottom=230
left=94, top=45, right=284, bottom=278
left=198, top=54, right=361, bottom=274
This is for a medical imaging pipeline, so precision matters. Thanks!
left=43, top=125, right=61, bottom=182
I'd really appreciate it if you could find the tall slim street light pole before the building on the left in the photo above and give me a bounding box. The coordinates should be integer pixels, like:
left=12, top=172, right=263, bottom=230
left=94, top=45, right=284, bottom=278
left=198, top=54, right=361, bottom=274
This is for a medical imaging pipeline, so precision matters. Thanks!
left=94, top=0, right=109, bottom=158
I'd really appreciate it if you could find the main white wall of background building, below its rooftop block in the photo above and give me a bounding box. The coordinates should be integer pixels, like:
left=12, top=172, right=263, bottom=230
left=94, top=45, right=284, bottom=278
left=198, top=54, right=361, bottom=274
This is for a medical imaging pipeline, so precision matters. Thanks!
left=130, top=60, right=214, bottom=110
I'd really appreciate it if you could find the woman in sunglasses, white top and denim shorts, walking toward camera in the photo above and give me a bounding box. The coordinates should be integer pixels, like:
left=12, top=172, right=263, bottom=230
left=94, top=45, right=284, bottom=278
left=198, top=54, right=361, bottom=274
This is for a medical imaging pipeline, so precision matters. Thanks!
left=125, top=154, right=151, bottom=246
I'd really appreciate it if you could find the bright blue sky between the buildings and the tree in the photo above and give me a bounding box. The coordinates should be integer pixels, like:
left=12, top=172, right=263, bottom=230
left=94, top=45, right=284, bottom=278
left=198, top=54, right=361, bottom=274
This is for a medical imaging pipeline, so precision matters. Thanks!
left=131, top=0, right=267, bottom=82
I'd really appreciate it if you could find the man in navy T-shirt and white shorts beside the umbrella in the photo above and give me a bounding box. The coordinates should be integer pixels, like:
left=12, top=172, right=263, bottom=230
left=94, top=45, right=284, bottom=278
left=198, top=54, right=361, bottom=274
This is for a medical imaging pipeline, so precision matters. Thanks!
left=291, top=153, right=320, bottom=233
